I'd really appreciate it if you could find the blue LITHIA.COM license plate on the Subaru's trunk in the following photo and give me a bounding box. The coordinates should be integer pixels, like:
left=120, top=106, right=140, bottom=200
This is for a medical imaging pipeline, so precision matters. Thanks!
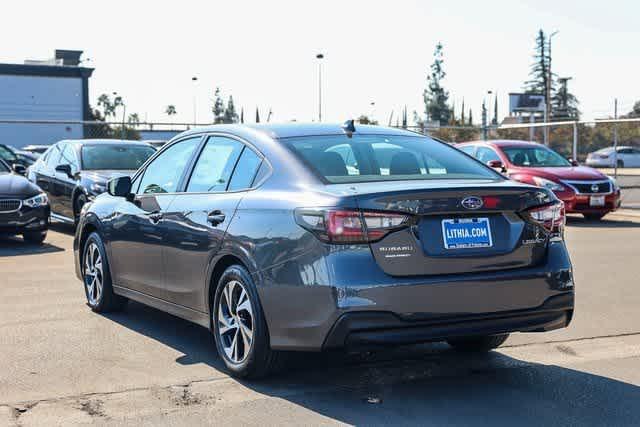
left=442, top=218, right=493, bottom=249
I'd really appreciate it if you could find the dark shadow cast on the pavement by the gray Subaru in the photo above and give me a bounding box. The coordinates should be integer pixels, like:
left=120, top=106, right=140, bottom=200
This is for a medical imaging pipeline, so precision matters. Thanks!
left=101, top=303, right=640, bottom=426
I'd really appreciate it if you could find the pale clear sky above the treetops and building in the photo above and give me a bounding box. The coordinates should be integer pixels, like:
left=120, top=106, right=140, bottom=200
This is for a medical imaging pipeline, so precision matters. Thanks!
left=0, top=0, right=640, bottom=124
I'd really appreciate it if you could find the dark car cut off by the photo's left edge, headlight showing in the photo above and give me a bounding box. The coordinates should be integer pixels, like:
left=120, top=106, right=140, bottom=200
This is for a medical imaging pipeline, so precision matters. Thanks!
left=0, top=160, right=49, bottom=244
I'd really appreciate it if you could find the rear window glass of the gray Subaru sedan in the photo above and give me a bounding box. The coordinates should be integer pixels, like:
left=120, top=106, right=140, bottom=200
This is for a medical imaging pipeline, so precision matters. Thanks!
left=282, top=135, right=501, bottom=184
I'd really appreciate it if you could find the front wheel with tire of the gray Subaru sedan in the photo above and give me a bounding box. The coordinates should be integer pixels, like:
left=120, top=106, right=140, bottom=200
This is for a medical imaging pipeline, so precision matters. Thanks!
left=82, top=232, right=127, bottom=313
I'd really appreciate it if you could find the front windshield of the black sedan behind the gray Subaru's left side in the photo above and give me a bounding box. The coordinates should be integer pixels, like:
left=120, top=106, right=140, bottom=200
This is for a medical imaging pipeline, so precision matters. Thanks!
left=82, top=144, right=155, bottom=170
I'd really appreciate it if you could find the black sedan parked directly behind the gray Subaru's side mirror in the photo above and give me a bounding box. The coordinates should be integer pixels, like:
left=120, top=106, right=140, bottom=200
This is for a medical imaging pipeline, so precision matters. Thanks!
left=28, top=139, right=156, bottom=227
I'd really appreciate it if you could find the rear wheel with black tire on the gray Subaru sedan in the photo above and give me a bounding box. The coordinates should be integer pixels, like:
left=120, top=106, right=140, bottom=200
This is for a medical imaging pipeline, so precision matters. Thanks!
left=211, top=265, right=282, bottom=378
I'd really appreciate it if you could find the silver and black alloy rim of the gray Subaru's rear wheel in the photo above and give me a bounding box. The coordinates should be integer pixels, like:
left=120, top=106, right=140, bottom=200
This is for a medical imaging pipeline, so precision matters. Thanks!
left=217, top=280, right=254, bottom=364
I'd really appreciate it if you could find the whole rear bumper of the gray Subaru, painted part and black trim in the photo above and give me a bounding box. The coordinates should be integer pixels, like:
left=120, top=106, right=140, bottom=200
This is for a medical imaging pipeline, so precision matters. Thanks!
left=258, top=242, right=574, bottom=351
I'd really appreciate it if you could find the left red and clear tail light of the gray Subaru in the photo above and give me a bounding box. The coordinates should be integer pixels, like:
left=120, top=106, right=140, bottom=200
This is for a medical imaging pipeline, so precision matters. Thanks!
left=295, top=209, right=410, bottom=244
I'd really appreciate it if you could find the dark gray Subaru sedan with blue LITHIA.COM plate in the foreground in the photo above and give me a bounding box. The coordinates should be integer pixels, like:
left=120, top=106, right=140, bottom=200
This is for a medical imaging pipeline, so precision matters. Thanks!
left=74, top=121, right=574, bottom=377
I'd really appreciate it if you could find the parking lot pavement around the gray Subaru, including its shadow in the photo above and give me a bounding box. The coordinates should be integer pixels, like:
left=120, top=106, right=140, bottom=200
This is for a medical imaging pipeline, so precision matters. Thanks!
left=0, top=214, right=640, bottom=426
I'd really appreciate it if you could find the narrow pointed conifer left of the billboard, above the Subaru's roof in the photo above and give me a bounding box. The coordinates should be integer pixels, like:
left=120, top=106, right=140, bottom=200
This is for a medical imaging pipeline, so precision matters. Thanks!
left=422, top=43, right=451, bottom=125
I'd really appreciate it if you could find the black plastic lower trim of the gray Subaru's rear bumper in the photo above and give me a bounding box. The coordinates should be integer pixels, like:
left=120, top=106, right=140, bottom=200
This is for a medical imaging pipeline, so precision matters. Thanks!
left=323, top=292, right=574, bottom=349
